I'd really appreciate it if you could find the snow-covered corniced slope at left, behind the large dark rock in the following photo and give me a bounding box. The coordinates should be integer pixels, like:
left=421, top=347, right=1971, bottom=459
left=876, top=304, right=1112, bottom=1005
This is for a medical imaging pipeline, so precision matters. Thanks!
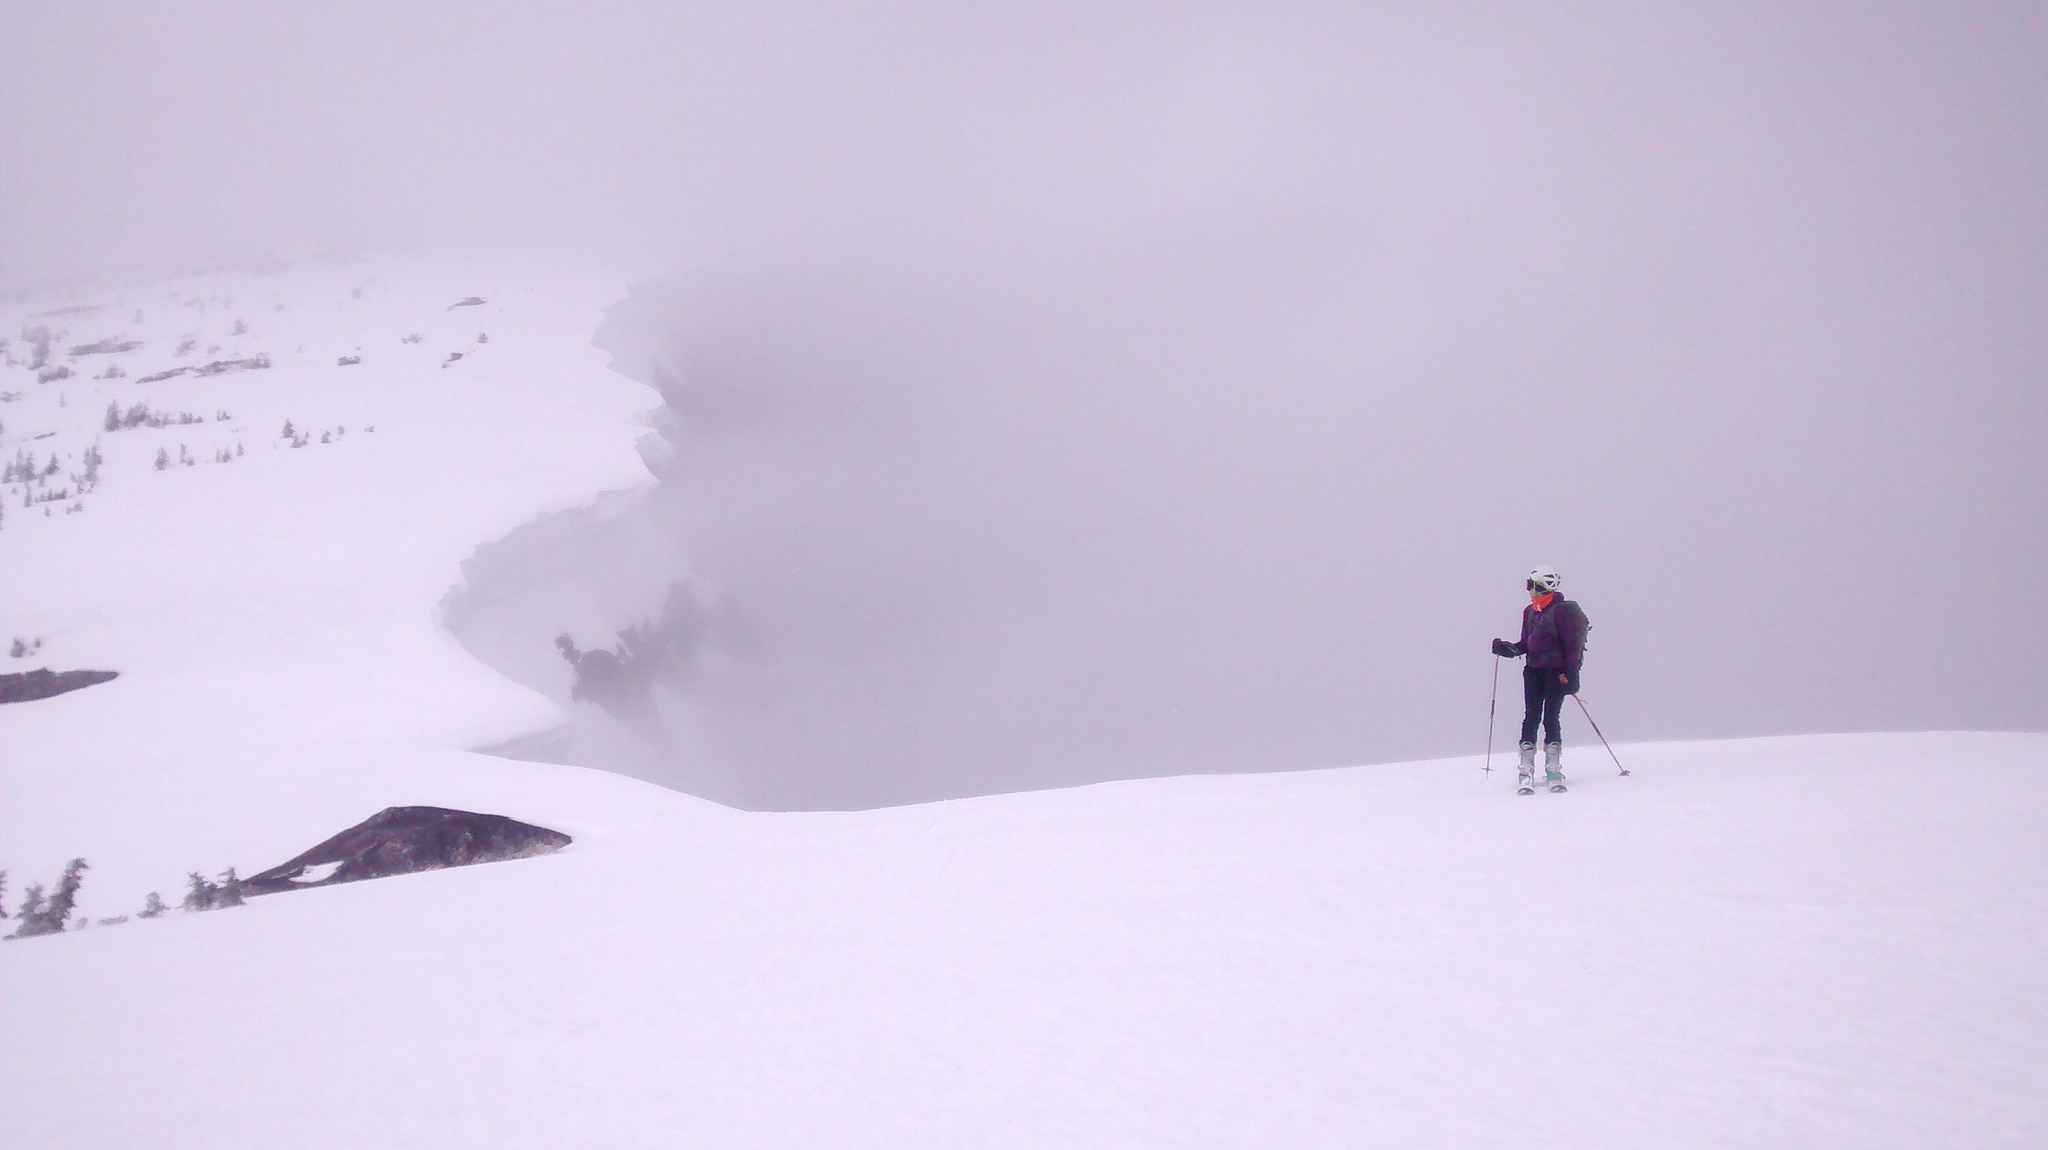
left=0, top=260, right=657, bottom=915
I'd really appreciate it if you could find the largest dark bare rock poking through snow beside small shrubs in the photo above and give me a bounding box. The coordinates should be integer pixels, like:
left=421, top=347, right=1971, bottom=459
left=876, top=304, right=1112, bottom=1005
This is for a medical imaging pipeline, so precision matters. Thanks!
left=242, top=806, right=569, bottom=894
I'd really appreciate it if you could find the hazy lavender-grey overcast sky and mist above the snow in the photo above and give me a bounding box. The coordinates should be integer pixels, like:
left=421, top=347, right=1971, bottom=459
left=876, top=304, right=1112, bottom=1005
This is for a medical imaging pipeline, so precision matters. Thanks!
left=0, top=2, right=2048, bottom=804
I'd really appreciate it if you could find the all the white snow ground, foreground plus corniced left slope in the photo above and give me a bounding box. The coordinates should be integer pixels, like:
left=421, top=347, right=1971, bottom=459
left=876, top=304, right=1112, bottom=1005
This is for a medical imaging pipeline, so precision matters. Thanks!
left=0, top=264, right=2048, bottom=1150
